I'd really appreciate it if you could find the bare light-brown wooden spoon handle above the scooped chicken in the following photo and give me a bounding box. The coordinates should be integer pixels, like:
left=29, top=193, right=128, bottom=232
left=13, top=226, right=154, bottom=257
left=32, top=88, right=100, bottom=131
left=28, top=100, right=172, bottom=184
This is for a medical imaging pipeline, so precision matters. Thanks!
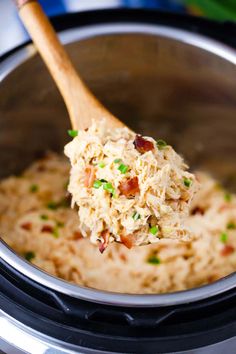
left=16, top=0, right=124, bottom=130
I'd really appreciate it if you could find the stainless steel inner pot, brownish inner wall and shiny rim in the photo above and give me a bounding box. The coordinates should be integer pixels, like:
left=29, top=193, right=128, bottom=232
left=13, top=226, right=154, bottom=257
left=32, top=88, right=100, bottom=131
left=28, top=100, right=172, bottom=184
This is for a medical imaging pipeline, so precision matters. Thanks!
left=0, top=23, right=236, bottom=306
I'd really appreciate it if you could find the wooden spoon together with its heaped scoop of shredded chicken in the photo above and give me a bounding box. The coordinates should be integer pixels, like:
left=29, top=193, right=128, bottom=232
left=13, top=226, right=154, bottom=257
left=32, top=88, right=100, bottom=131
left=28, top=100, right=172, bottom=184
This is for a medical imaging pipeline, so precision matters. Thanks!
left=17, top=0, right=198, bottom=252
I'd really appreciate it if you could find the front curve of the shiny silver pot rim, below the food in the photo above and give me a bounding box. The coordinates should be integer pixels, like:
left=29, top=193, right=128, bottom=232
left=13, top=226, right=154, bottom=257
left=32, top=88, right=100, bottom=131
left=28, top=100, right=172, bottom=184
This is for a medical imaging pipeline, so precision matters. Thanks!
left=0, top=242, right=236, bottom=307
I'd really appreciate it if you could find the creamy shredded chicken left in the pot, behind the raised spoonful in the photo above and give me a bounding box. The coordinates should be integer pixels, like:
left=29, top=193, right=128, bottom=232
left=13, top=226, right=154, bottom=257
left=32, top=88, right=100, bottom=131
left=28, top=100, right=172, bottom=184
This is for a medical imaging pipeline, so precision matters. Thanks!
left=0, top=155, right=236, bottom=294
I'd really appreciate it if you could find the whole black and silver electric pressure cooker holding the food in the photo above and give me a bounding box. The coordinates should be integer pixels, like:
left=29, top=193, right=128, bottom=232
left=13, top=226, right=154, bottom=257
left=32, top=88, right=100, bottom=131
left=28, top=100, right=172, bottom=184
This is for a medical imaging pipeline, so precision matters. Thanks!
left=0, top=10, right=236, bottom=354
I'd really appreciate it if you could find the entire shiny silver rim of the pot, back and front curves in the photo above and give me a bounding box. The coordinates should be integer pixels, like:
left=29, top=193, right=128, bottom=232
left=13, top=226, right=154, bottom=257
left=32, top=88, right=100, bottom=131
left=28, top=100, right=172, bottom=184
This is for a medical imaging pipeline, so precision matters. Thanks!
left=0, top=22, right=236, bottom=307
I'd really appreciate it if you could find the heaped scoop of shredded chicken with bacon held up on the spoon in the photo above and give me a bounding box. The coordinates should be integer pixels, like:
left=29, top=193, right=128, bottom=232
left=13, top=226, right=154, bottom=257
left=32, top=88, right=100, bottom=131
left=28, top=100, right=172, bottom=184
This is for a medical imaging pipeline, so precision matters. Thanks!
left=65, top=121, right=197, bottom=252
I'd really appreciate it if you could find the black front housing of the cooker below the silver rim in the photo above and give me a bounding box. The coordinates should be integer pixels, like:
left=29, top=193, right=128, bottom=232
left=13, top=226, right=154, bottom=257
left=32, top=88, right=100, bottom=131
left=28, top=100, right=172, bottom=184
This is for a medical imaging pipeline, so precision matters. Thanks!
left=0, top=254, right=236, bottom=354
